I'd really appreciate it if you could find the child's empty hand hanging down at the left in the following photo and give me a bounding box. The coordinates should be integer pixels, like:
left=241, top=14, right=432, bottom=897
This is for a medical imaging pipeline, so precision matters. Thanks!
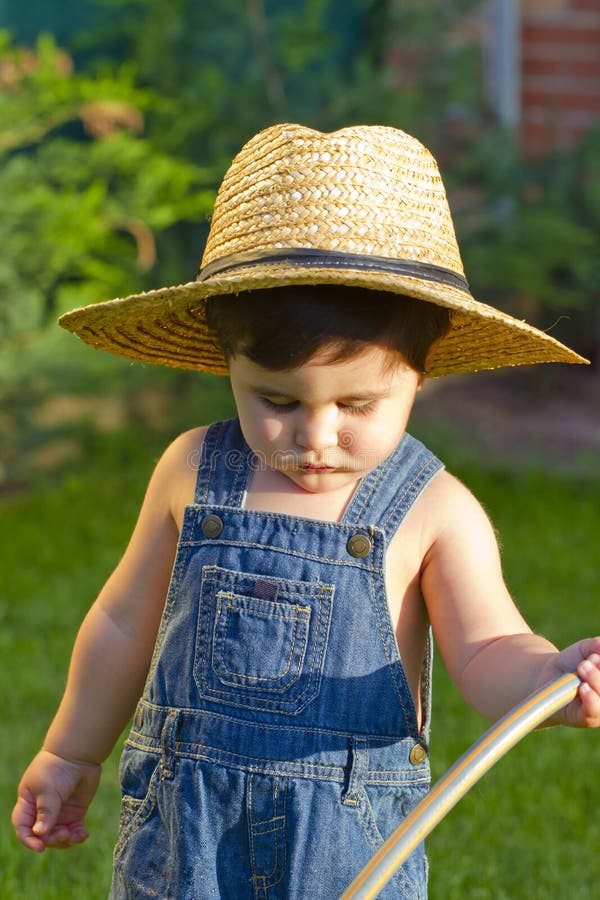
left=12, top=750, right=101, bottom=853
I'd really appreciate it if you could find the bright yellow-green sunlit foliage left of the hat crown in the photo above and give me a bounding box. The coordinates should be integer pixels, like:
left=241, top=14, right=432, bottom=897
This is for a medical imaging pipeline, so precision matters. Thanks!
left=0, top=33, right=214, bottom=339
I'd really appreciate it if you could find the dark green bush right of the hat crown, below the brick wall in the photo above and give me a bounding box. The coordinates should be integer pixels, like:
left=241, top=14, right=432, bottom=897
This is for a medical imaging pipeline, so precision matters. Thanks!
left=453, top=131, right=600, bottom=336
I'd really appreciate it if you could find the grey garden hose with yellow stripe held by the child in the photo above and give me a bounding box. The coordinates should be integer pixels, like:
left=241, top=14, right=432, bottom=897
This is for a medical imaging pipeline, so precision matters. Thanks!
left=340, top=673, right=581, bottom=900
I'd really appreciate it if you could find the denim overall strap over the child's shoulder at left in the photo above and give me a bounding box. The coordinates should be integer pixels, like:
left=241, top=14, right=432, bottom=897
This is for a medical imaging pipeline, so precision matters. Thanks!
left=194, top=419, right=252, bottom=507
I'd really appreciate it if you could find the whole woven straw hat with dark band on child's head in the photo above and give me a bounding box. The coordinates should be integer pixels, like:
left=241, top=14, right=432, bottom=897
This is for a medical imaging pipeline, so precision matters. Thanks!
left=59, top=124, right=586, bottom=375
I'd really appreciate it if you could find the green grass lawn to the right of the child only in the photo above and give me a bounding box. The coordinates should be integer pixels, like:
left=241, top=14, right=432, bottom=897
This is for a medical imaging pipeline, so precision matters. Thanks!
left=428, top=468, right=600, bottom=900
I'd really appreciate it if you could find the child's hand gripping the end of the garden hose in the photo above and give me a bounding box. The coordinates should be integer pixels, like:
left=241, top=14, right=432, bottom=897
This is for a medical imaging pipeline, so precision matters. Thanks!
left=543, top=638, right=600, bottom=728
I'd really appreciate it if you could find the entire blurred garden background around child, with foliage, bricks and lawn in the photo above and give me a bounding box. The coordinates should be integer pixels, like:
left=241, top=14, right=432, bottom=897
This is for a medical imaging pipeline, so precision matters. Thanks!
left=0, top=0, right=600, bottom=900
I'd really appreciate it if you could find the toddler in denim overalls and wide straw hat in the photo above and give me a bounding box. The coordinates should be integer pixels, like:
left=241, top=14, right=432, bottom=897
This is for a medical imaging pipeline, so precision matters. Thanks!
left=13, top=125, right=600, bottom=900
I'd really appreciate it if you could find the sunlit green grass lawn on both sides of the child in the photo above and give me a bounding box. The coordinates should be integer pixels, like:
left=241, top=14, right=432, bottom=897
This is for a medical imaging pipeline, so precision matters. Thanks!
left=0, top=424, right=600, bottom=900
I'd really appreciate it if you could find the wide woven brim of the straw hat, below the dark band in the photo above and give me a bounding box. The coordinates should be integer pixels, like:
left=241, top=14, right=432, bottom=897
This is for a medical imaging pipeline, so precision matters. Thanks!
left=59, top=264, right=588, bottom=377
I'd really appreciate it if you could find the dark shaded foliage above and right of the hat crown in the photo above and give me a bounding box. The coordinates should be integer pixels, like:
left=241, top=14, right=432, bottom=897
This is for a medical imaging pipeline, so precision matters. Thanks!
left=81, top=0, right=600, bottom=350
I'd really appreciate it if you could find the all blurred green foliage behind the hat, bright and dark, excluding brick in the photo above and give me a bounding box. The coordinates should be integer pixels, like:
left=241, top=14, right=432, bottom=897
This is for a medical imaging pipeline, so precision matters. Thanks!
left=0, top=0, right=600, bottom=492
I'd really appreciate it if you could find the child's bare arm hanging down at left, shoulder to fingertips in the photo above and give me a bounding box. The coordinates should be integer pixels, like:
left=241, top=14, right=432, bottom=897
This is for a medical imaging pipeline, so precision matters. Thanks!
left=13, top=432, right=199, bottom=851
